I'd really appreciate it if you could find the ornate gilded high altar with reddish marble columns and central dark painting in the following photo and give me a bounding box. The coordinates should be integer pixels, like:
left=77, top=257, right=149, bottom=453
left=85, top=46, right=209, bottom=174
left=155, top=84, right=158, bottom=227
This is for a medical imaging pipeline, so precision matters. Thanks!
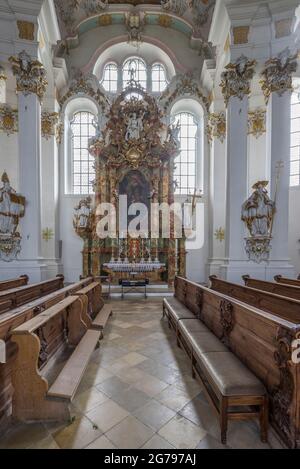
left=74, top=79, right=186, bottom=285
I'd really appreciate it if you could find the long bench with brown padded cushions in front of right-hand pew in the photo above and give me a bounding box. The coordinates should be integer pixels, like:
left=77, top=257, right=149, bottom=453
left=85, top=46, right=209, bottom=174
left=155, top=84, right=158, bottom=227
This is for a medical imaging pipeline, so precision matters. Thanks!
left=163, top=292, right=268, bottom=444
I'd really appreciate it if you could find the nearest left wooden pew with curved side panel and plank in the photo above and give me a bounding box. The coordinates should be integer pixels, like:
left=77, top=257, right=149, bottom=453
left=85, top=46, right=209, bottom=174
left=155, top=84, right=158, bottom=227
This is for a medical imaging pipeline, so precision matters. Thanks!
left=12, top=296, right=100, bottom=422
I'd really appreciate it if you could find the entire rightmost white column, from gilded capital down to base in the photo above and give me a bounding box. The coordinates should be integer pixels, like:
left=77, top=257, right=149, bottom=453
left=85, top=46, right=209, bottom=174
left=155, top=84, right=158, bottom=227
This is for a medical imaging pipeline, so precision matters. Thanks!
left=262, top=49, right=297, bottom=280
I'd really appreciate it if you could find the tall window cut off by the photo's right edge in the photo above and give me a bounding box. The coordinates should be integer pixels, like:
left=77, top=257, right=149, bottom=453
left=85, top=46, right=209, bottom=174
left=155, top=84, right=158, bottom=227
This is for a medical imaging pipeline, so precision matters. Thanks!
left=290, top=91, right=300, bottom=186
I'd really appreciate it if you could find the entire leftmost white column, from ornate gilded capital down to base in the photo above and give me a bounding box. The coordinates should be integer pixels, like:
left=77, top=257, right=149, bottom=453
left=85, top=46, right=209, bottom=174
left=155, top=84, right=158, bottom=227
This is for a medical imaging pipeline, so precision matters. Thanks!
left=10, top=51, right=47, bottom=282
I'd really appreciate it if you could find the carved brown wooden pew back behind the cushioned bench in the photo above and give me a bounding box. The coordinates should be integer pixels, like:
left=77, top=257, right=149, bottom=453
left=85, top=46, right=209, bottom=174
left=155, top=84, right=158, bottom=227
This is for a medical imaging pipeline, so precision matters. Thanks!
left=166, top=278, right=300, bottom=448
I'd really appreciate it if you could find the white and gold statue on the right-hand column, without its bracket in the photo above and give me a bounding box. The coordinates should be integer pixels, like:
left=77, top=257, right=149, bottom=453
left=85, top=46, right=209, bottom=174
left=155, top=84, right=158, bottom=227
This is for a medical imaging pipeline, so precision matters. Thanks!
left=242, top=181, right=275, bottom=238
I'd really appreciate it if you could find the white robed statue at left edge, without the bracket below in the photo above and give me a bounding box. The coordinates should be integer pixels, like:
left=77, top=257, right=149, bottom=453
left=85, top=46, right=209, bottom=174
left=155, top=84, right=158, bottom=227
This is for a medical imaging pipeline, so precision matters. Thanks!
left=0, top=173, right=25, bottom=236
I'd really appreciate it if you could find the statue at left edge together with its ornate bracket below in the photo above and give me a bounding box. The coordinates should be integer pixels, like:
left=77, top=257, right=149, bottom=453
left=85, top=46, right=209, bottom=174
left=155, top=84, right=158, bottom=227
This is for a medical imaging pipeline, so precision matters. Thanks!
left=0, top=173, right=25, bottom=262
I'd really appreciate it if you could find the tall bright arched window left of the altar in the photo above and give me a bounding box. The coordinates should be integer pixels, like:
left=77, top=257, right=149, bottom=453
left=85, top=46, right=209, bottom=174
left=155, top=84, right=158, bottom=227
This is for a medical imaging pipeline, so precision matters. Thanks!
left=71, top=111, right=96, bottom=195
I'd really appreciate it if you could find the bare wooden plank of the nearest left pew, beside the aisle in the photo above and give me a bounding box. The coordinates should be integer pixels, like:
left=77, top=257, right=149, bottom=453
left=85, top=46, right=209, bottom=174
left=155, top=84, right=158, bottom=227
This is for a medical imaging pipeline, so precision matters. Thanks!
left=47, top=330, right=101, bottom=401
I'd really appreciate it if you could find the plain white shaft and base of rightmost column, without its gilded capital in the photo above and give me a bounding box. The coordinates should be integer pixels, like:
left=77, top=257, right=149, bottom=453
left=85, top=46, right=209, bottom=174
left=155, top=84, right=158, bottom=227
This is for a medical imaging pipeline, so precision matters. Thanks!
left=267, top=91, right=295, bottom=279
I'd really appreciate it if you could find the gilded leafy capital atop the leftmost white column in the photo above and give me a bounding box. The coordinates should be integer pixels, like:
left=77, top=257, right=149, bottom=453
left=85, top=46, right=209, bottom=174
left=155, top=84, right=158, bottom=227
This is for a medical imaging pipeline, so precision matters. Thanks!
left=9, top=51, right=48, bottom=100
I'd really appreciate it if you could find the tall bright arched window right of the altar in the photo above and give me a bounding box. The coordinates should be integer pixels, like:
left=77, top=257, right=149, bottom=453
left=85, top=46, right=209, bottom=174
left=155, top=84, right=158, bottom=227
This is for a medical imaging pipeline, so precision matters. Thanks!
left=174, top=112, right=198, bottom=195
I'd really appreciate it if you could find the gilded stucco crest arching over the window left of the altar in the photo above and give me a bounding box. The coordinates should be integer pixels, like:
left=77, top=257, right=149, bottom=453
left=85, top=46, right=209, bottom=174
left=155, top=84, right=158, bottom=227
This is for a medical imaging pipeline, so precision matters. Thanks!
left=59, top=71, right=109, bottom=112
